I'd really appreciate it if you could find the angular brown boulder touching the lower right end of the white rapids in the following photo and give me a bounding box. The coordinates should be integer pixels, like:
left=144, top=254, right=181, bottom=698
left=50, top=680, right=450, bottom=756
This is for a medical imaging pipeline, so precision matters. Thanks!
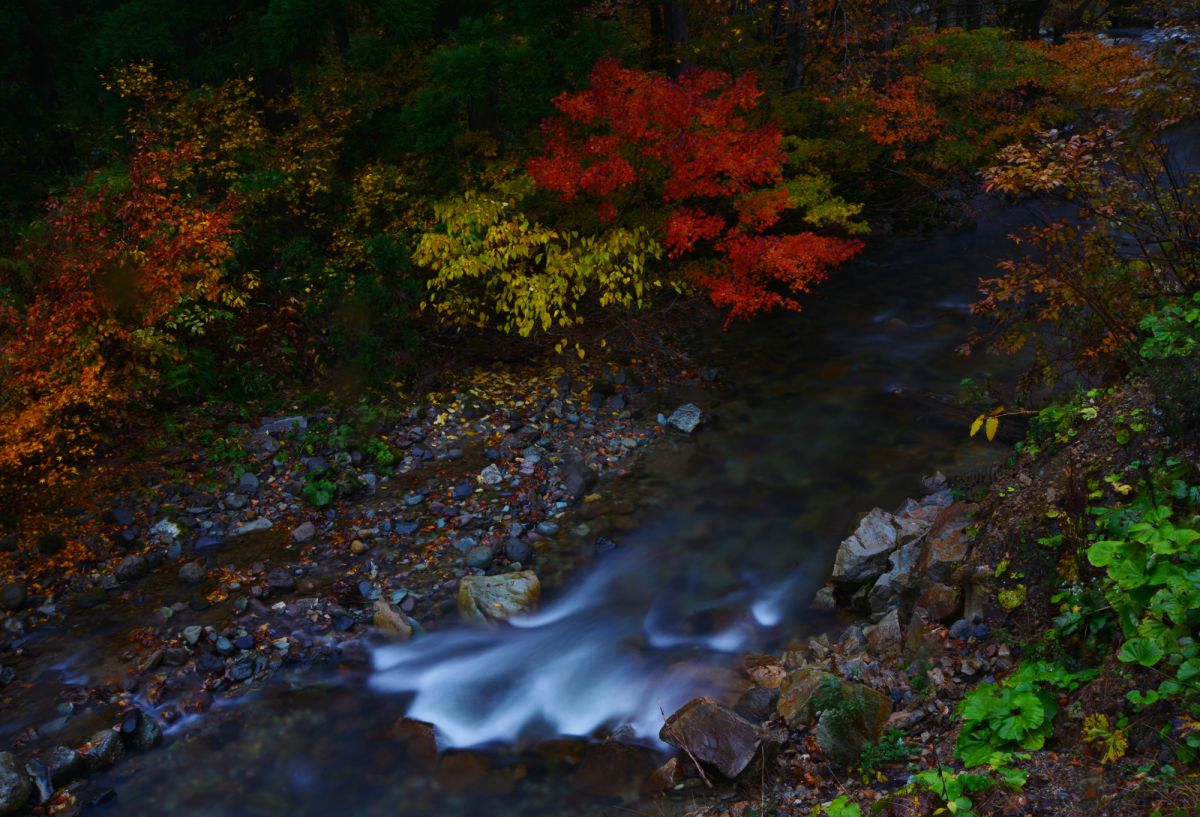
left=659, top=698, right=763, bottom=780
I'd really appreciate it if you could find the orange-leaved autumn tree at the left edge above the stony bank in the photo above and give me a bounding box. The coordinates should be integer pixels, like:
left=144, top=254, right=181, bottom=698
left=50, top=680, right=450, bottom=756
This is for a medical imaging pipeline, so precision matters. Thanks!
left=0, top=145, right=246, bottom=479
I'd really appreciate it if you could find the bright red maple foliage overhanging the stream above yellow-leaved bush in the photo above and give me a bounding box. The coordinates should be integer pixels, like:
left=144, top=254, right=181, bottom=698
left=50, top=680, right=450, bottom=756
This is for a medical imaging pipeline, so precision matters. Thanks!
left=528, top=59, right=862, bottom=320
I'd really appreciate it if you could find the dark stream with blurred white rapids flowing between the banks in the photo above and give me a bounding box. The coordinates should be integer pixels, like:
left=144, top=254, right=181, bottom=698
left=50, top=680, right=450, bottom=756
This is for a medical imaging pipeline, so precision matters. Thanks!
left=77, top=203, right=1020, bottom=817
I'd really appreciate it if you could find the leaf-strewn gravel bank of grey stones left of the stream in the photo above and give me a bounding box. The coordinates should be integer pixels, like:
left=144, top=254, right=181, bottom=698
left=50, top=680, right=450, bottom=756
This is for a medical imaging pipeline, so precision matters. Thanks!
left=0, top=352, right=716, bottom=815
